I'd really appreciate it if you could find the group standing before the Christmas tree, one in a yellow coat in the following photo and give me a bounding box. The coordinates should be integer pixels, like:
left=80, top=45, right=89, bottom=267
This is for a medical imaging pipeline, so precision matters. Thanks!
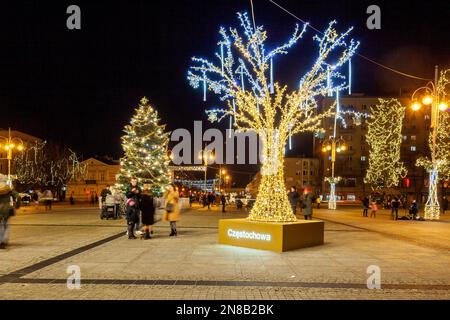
left=126, top=177, right=180, bottom=240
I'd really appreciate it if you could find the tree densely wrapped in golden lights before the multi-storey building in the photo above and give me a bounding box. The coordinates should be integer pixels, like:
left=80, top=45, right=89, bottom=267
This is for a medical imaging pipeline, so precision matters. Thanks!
left=364, top=99, right=407, bottom=190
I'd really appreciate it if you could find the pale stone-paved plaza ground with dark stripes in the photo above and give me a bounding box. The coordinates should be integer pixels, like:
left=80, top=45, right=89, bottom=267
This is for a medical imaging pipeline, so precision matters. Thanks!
left=0, top=206, right=450, bottom=300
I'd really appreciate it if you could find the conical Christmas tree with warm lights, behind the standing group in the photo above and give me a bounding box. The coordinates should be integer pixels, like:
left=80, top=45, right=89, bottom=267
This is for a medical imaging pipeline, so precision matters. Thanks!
left=117, top=97, right=170, bottom=193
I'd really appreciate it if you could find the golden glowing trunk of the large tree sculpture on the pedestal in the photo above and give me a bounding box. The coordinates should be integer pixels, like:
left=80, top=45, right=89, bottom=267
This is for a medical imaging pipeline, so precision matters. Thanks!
left=249, top=131, right=297, bottom=222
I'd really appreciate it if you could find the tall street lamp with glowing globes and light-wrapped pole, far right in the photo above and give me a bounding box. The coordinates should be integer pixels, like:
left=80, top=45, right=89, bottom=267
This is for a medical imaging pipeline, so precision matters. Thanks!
left=411, top=66, right=448, bottom=220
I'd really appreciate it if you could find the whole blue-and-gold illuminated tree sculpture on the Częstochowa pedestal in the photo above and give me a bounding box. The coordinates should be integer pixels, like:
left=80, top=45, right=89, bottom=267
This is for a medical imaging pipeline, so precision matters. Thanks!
left=188, top=13, right=359, bottom=222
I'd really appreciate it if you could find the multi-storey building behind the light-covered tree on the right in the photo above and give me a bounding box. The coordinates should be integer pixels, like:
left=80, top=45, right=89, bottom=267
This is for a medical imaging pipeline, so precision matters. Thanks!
left=314, top=95, right=430, bottom=200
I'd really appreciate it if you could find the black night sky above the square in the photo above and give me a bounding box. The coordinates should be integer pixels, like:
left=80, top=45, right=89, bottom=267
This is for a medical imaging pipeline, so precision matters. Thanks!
left=0, top=0, right=450, bottom=158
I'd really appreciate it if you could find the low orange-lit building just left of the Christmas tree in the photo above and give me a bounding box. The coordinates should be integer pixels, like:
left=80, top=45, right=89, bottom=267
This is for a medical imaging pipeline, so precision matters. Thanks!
left=66, top=158, right=120, bottom=201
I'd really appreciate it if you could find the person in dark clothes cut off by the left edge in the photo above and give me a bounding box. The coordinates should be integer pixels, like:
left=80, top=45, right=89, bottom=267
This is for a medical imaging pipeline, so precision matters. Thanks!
left=0, top=175, right=20, bottom=249
